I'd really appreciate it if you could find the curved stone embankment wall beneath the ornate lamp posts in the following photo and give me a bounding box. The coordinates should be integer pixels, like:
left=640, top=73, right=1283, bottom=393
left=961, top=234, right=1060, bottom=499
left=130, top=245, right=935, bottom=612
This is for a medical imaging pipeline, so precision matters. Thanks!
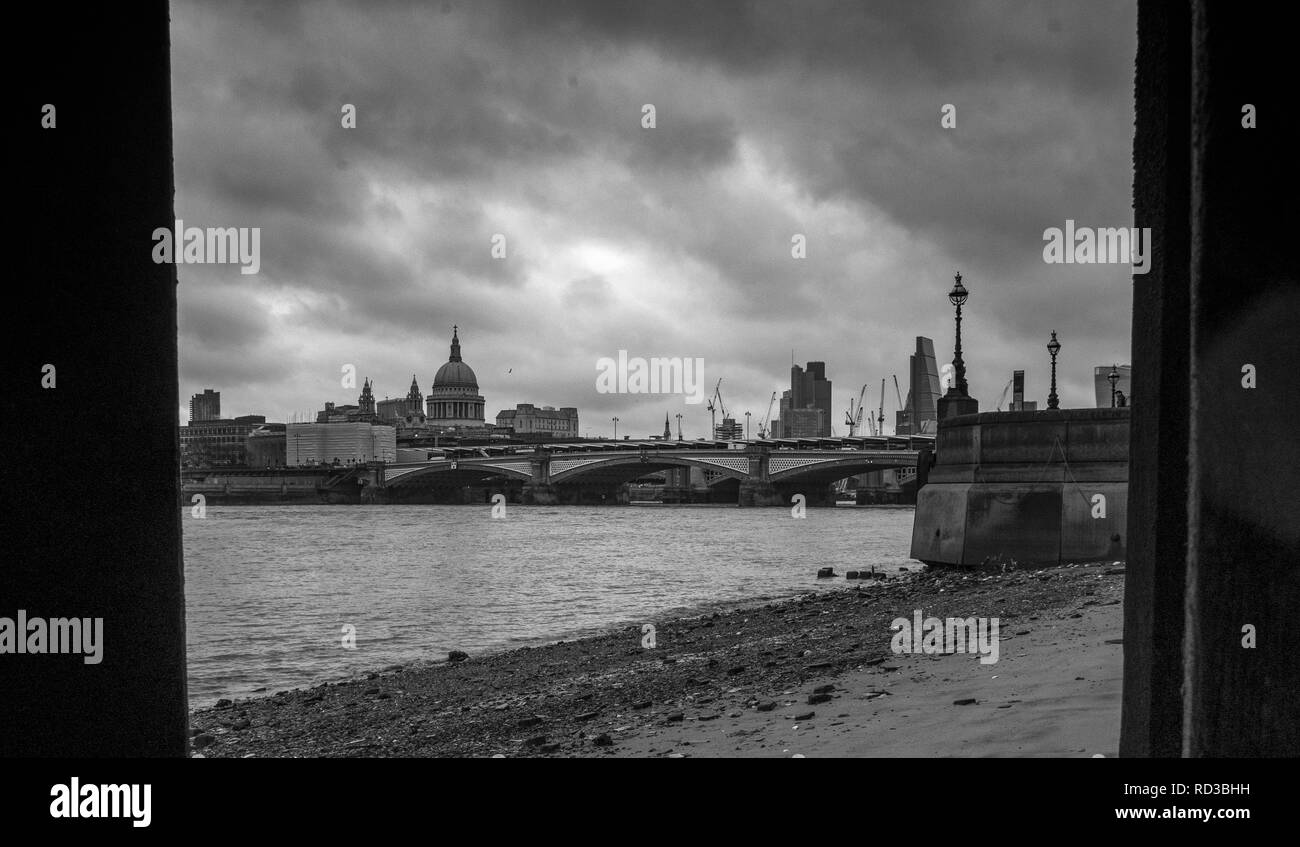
left=911, top=409, right=1130, bottom=565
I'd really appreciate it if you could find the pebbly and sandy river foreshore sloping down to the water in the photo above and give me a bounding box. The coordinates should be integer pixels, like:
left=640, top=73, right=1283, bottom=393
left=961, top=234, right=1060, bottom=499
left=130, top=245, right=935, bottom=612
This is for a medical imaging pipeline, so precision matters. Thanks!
left=191, top=563, right=1123, bottom=757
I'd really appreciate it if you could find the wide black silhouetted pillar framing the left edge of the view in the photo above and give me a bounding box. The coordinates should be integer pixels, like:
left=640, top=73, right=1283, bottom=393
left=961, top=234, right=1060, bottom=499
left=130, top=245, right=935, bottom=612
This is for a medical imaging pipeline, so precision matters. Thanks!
left=0, top=0, right=187, bottom=756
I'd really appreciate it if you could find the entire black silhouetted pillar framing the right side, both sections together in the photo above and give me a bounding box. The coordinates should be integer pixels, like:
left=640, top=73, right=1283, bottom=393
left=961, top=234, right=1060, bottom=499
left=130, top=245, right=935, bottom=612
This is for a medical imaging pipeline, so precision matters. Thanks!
left=1121, top=0, right=1300, bottom=756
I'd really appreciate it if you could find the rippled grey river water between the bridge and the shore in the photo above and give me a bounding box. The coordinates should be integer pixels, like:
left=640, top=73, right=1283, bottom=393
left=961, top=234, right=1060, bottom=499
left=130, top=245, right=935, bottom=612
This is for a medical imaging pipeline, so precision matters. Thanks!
left=183, top=505, right=919, bottom=705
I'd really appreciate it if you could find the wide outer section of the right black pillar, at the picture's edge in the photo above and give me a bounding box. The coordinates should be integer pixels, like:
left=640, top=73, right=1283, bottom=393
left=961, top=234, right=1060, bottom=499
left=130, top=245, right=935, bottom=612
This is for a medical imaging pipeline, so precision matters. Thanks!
left=1183, top=0, right=1300, bottom=756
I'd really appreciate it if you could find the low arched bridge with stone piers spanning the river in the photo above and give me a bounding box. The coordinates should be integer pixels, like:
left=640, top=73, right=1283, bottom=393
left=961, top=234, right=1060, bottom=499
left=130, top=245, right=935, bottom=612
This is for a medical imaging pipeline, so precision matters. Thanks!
left=367, top=435, right=935, bottom=505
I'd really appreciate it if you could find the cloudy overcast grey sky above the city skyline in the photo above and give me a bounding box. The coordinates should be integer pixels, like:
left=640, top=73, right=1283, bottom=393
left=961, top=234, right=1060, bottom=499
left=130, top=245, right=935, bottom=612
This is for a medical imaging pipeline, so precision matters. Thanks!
left=172, top=0, right=1141, bottom=438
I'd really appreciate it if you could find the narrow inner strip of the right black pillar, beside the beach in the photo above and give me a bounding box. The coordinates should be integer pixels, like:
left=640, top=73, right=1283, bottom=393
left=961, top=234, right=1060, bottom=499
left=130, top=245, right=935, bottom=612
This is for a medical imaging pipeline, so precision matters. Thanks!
left=1119, top=0, right=1192, bottom=756
